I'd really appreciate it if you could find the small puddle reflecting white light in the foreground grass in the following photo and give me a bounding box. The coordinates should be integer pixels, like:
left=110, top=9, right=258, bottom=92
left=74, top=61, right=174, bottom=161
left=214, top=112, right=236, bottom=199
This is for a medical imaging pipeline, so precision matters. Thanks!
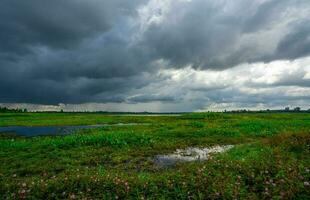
left=155, top=145, right=234, bottom=166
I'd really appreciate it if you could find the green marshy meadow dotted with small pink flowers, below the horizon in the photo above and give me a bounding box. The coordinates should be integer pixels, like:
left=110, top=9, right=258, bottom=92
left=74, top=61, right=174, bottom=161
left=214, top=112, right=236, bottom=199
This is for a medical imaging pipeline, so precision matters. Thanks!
left=0, top=113, right=310, bottom=199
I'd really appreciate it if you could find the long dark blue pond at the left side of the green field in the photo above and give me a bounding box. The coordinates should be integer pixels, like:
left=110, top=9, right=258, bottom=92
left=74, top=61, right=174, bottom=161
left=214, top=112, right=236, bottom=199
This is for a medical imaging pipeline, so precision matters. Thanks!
left=0, top=123, right=143, bottom=137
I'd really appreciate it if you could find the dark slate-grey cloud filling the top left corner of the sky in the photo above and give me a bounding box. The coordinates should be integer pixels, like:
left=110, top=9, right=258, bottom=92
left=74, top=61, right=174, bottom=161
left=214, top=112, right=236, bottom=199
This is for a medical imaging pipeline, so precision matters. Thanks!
left=0, top=0, right=143, bottom=53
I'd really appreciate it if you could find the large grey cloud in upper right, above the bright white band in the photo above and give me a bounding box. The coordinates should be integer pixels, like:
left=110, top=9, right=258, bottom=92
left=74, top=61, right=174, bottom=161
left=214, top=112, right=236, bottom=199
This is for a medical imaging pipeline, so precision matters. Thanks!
left=143, top=0, right=310, bottom=69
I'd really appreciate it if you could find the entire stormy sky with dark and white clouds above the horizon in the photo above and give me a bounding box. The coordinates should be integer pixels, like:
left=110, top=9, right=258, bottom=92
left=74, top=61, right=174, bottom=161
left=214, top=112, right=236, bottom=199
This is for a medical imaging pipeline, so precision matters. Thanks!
left=0, top=0, right=310, bottom=112
